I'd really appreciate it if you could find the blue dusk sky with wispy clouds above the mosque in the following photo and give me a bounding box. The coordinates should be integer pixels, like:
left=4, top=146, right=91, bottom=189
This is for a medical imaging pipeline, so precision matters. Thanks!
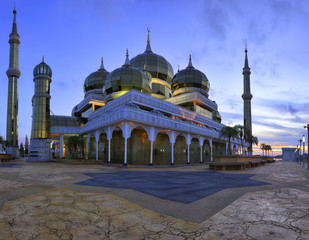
left=0, top=0, right=309, bottom=155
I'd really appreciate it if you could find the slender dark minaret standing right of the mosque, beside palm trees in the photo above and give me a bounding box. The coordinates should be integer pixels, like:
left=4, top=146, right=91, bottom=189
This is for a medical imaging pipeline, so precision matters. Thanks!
left=242, top=46, right=252, bottom=155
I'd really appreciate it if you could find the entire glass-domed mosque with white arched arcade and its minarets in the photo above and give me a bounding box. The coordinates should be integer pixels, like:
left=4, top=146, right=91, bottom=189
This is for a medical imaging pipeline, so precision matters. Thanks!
left=7, top=9, right=252, bottom=165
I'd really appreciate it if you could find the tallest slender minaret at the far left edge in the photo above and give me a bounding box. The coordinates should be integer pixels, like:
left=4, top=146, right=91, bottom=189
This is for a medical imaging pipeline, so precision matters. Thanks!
left=6, top=7, right=20, bottom=156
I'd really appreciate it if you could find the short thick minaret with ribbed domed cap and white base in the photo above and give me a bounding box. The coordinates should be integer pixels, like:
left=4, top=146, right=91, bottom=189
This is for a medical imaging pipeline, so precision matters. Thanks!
left=28, top=57, right=52, bottom=161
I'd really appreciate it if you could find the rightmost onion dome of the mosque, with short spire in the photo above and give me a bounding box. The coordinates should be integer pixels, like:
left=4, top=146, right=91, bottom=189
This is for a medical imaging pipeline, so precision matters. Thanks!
left=172, top=55, right=210, bottom=97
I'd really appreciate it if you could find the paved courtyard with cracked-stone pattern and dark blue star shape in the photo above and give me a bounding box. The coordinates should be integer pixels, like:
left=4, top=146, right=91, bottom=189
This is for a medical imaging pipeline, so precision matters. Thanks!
left=0, top=160, right=309, bottom=240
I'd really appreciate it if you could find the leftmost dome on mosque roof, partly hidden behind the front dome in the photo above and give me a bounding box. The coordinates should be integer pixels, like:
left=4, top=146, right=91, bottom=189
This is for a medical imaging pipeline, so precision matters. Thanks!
left=84, top=58, right=108, bottom=95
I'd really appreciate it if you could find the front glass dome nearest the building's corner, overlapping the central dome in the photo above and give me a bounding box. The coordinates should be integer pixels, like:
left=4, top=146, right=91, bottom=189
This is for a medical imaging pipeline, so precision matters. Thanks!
left=103, top=50, right=151, bottom=98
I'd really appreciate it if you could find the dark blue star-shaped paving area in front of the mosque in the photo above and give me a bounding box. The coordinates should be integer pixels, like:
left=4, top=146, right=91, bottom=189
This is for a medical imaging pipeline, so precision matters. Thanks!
left=78, top=171, right=268, bottom=203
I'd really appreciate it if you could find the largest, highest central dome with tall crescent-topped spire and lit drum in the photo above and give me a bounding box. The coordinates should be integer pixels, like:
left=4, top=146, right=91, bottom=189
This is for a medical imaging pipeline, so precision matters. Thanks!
left=130, top=32, right=174, bottom=98
